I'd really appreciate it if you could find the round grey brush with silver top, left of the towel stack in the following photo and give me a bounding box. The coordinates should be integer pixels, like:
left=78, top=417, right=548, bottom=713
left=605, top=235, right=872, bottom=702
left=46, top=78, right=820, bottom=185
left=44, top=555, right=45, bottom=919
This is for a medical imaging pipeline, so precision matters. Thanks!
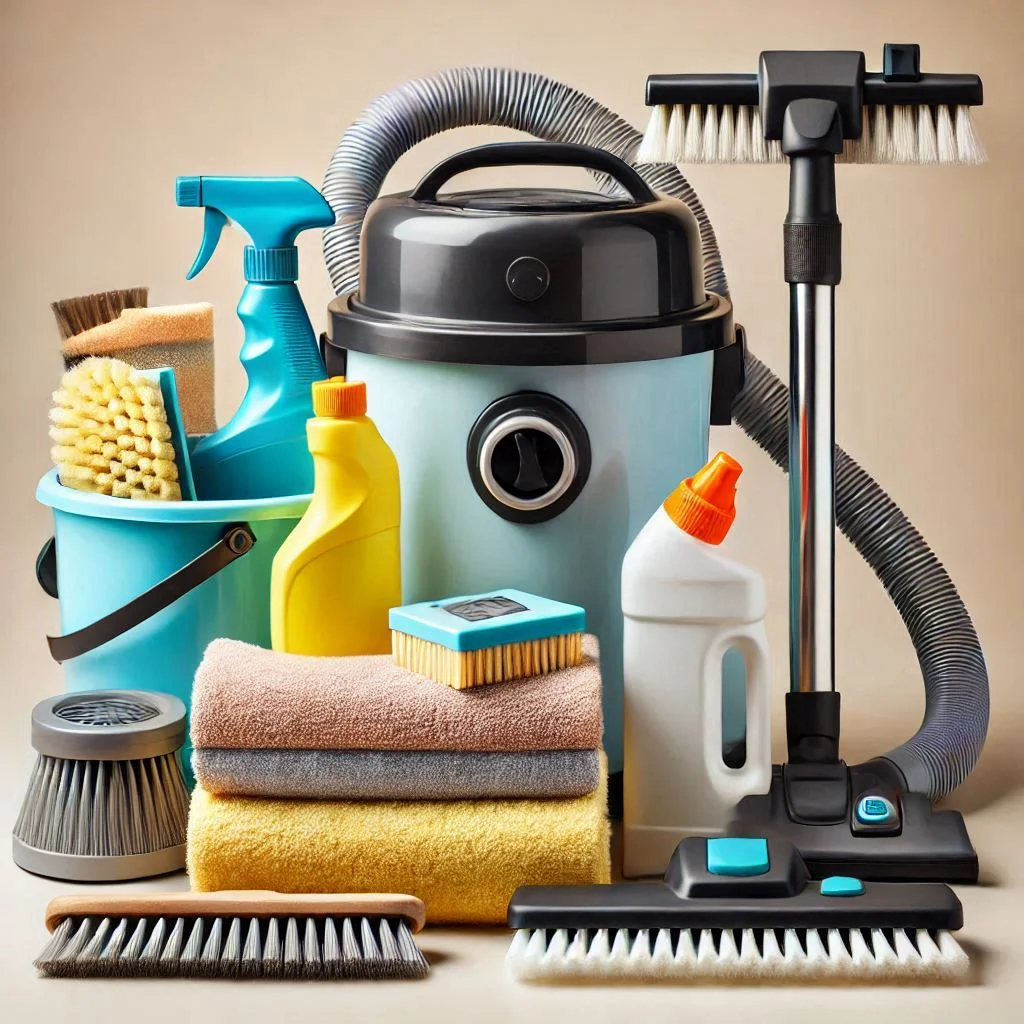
left=13, top=690, right=188, bottom=882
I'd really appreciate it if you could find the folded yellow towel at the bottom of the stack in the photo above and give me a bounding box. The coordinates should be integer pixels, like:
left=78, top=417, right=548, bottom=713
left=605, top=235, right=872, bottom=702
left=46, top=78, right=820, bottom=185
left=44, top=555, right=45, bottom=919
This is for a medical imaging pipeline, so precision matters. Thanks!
left=188, top=757, right=611, bottom=925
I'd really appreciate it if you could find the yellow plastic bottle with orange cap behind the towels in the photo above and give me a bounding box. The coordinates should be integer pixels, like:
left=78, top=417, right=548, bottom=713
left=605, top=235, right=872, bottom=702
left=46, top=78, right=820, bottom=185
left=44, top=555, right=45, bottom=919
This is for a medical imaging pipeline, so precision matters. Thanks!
left=270, top=377, right=401, bottom=655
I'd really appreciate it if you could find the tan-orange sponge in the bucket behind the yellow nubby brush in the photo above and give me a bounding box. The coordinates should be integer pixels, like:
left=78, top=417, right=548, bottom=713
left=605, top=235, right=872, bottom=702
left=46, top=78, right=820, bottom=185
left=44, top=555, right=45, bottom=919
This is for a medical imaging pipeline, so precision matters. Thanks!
left=63, top=302, right=217, bottom=434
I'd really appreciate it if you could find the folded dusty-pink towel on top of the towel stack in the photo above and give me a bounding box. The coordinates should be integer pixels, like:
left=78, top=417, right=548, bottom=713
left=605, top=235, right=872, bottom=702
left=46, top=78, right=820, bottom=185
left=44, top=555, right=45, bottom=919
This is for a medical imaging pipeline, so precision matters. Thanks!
left=191, top=636, right=601, bottom=752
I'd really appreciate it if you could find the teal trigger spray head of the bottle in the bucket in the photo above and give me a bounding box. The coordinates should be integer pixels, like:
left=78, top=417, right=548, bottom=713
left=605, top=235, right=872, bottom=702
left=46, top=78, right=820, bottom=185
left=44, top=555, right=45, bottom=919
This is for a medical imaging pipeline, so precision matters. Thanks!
left=175, top=175, right=334, bottom=281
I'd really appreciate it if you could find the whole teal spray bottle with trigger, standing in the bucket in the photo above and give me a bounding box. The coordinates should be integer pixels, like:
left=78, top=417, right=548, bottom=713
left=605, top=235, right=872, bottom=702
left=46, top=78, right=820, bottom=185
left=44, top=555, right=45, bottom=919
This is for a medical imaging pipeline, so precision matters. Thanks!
left=177, top=176, right=334, bottom=501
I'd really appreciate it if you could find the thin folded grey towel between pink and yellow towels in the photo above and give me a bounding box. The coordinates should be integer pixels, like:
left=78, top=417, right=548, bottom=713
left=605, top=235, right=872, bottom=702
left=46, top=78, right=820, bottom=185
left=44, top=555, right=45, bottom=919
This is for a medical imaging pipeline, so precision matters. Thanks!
left=193, top=748, right=600, bottom=800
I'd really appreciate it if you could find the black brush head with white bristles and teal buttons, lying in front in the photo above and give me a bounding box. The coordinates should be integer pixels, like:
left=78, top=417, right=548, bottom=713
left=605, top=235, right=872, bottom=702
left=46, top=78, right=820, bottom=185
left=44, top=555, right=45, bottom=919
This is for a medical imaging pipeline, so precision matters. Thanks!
left=506, top=838, right=969, bottom=985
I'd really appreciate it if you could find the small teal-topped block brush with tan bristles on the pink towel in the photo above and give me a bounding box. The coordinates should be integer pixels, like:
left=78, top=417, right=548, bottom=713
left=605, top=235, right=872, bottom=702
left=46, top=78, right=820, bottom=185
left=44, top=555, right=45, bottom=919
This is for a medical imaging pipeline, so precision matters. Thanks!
left=389, top=590, right=587, bottom=689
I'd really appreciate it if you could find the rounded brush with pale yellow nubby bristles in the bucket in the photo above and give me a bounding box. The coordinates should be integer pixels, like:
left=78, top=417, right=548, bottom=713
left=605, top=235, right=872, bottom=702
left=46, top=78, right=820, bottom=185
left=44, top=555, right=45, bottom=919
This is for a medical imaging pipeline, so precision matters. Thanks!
left=50, top=357, right=195, bottom=501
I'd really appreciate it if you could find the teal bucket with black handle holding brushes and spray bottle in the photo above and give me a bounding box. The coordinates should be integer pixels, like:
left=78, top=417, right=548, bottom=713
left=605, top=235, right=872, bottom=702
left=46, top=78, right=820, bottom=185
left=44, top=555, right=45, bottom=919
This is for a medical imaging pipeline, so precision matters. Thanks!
left=36, top=469, right=309, bottom=782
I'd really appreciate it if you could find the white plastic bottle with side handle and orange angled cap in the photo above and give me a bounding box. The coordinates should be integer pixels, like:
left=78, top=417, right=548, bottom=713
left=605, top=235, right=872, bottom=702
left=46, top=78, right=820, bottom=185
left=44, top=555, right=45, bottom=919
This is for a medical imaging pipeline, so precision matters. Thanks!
left=623, top=453, right=771, bottom=878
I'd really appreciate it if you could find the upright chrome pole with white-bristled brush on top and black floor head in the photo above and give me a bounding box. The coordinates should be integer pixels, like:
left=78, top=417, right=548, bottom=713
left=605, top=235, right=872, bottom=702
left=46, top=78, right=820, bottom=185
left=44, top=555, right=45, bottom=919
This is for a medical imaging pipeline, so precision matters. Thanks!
left=640, top=44, right=988, bottom=882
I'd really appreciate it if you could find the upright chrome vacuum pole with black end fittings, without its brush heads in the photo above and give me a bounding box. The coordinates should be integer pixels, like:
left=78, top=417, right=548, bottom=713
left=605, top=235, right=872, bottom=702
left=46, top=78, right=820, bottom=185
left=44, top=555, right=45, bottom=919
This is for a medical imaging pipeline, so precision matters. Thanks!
left=782, top=99, right=843, bottom=764
